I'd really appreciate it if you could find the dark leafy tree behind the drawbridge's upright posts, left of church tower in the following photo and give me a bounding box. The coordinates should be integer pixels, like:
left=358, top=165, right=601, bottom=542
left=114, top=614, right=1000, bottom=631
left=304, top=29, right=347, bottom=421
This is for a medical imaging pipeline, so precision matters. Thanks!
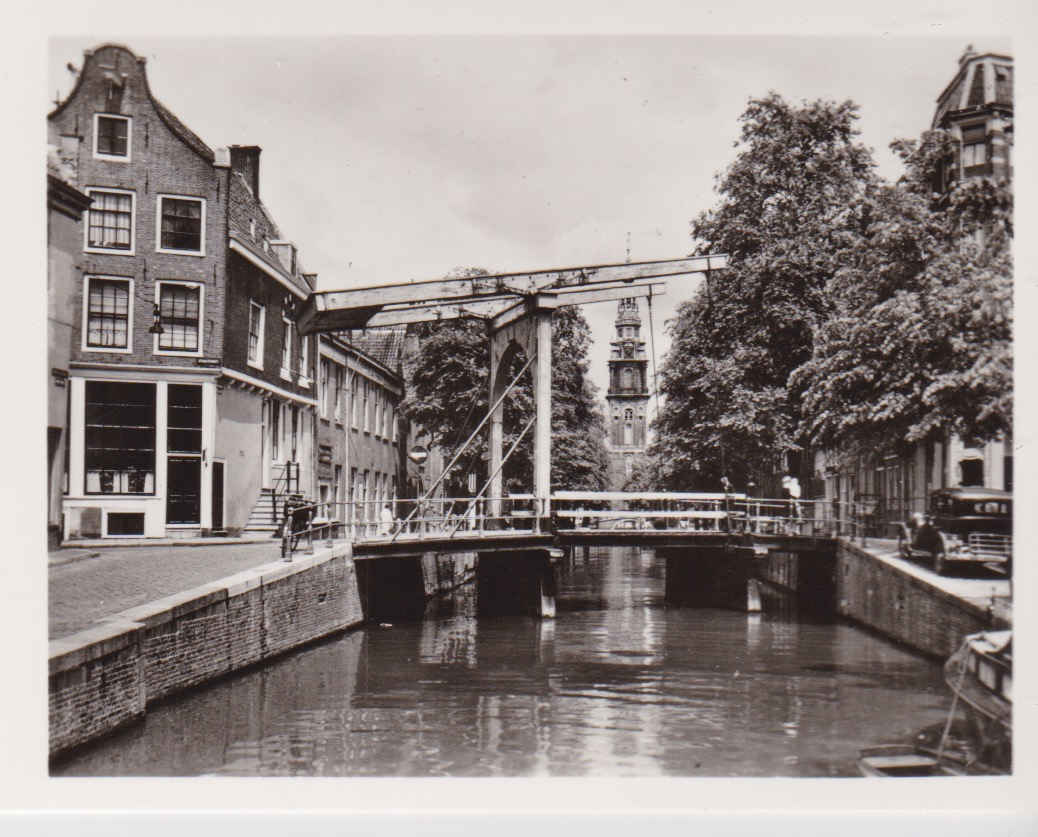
left=403, top=269, right=606, bottom=495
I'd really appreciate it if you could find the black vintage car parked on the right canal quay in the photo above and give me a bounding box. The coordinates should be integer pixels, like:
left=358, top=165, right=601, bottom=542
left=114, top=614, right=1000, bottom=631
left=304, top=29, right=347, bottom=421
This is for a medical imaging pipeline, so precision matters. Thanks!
left=898, top=486, right=1013, bottom=575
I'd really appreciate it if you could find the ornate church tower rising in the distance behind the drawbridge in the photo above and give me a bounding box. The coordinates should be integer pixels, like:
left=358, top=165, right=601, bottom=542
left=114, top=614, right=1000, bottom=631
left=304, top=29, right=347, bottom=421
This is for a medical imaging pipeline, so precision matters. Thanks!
left=605, top=298, right=649, bottom=490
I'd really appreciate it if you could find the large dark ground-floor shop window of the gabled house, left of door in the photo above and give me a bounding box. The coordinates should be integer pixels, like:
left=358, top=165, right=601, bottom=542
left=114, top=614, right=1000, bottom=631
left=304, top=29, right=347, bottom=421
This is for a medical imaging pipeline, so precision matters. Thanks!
left=83, top=381, right=155, bottom=494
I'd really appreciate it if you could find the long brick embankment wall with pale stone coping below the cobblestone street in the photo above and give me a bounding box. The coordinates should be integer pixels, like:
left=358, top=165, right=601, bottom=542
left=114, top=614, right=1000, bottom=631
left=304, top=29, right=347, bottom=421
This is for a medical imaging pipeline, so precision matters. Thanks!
left=50, top=546, right=364, bottom=757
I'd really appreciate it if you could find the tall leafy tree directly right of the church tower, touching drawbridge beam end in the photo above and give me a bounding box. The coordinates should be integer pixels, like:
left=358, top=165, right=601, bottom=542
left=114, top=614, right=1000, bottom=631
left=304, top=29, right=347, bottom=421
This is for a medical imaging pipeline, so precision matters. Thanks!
left=654, top=92, right=875, bottom=489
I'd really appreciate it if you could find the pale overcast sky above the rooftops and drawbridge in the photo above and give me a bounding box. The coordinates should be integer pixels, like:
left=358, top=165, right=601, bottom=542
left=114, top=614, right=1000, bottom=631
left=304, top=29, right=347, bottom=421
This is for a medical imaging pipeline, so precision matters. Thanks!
left=49, top=35, right=1011, bottom=409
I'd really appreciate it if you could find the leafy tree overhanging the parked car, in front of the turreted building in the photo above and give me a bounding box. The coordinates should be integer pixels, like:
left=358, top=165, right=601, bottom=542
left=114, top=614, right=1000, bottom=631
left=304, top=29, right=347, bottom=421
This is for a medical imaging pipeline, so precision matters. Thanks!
left=794, top=131, right=1013, bottom=454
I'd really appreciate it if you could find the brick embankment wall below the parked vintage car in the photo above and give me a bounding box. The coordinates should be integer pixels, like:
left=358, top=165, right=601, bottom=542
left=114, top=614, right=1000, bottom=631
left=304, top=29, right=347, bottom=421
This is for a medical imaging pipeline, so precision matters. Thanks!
left=837, top=541, right=1008, bottom=658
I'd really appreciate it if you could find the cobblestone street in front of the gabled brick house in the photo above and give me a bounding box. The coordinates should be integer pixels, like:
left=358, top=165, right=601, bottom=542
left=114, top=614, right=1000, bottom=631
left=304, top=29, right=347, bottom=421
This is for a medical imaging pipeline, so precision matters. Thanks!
left=48, top=539, right=280, bottom=640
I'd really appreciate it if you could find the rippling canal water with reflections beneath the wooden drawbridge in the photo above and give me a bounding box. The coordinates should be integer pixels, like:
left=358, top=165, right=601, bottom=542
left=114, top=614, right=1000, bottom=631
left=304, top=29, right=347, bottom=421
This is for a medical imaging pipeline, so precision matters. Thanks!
left=52, top=548, right=951, bottom=777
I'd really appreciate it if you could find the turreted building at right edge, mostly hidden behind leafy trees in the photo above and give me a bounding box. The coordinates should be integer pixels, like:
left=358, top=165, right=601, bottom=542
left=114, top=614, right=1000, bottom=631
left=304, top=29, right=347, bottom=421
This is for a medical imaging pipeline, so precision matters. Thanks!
left=813, top=48, right=1013, bottom=524
